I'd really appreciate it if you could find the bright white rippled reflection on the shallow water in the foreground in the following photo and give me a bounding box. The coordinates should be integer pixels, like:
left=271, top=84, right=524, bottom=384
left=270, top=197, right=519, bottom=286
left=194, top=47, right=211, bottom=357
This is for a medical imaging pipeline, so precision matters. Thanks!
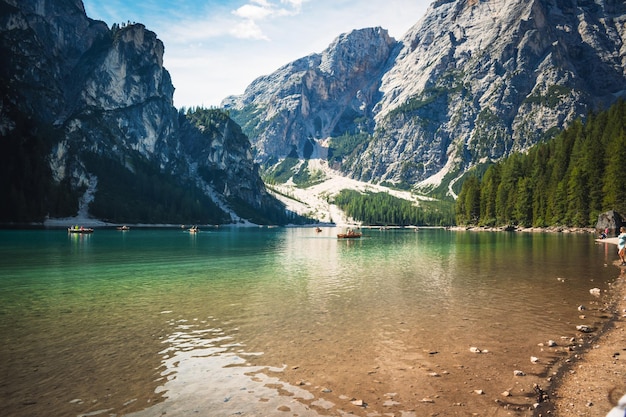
left=128, top=311, right=324, bottom=417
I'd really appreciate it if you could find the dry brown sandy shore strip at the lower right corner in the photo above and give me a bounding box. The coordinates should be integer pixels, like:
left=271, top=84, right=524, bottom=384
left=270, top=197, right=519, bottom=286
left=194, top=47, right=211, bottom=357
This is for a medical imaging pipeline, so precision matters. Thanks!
left=548, top=261, right=626, bottom=417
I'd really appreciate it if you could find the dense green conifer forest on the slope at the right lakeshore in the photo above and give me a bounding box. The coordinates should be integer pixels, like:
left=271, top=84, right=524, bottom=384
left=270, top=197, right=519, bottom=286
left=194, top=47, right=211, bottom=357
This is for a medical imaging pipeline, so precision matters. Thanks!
left=456, top=100, right=626, bottom=227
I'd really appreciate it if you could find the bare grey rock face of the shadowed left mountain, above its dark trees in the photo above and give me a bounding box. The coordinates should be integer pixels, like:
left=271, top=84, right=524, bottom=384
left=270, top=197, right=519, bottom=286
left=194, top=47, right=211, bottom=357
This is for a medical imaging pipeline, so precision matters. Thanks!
left=0, top=0, right=275, bottom=221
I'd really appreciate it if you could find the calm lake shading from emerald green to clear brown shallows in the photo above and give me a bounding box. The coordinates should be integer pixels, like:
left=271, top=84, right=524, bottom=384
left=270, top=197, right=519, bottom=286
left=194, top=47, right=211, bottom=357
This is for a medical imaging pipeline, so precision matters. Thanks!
left=0, top=227, right=619, bottom=417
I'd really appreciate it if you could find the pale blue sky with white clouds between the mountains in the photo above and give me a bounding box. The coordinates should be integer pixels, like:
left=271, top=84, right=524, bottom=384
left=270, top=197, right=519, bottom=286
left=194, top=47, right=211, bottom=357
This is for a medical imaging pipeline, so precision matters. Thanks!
left=83, top=0, right=432, bottom=107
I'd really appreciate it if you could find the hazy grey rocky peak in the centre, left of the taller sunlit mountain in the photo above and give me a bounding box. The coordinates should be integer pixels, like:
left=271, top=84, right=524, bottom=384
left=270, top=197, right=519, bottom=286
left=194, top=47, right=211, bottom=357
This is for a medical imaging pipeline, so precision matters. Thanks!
left=222, top=28, right=397, bottom=161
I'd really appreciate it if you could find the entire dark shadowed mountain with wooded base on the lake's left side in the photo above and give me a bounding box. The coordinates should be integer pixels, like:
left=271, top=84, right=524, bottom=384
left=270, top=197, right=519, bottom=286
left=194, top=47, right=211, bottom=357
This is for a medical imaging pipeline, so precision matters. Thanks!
left=0, top=0, right=287, bottom=223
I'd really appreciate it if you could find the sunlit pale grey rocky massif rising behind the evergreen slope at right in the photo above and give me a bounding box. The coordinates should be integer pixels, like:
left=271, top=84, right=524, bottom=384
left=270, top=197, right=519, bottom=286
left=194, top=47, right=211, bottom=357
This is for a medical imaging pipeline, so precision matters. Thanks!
left=222, top=0, right=626, bottom=195
